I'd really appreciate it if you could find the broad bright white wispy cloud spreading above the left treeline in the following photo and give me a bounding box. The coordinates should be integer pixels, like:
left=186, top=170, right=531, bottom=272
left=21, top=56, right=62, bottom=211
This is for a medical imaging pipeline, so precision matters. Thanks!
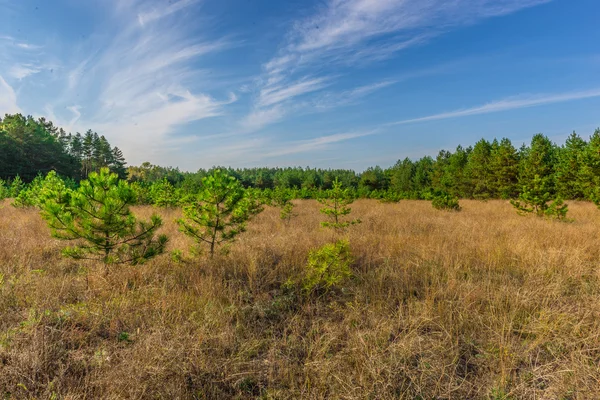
left=42, top=0, right=237, bottom=163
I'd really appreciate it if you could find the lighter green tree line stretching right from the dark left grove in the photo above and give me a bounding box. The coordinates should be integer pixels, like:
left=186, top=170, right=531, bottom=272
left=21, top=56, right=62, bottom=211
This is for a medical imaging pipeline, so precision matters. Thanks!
left=128, top=129, right=600, bottom=200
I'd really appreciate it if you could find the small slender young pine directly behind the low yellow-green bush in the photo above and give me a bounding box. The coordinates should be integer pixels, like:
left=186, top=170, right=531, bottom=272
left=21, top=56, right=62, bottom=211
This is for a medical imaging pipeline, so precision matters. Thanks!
left=318, top=179, right=360, bottom=231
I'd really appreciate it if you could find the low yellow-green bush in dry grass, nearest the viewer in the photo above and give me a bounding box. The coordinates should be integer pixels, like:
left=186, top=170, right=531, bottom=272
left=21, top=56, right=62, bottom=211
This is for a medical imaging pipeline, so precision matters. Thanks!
left=302, top=240, right=353, bottom=294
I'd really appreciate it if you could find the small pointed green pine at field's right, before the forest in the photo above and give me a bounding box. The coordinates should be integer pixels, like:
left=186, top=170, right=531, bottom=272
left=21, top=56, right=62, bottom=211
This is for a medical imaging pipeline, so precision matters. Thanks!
left=510, top=175, right=568, bottom=220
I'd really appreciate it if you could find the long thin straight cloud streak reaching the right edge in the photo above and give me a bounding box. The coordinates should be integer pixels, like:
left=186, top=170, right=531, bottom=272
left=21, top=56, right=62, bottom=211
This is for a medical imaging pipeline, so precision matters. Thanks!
left=387, top=88, right=600, bottom=125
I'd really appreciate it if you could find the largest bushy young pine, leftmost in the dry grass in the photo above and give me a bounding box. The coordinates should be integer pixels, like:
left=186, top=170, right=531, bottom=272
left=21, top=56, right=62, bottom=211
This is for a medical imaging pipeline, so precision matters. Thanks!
left=42, top=168, right=167, bottom=272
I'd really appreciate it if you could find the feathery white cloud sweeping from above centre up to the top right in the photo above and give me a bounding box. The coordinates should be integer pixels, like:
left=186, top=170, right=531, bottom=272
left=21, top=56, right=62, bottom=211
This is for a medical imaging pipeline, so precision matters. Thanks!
left=246, top=0, right=551, bottom=133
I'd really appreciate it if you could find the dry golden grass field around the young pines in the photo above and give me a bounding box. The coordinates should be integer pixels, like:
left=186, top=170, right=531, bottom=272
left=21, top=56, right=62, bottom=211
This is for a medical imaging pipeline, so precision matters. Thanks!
left=0, top=200, right=600, bottom=400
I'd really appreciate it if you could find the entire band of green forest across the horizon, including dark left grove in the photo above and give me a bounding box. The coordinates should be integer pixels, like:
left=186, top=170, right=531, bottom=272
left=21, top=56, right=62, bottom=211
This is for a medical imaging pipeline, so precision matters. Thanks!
left=0, top=114, right=600, bottom=203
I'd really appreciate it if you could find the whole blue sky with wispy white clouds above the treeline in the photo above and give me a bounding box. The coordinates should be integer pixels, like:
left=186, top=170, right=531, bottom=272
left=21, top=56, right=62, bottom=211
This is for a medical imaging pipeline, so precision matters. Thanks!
left=0, top=0, right=600, bottom=170
